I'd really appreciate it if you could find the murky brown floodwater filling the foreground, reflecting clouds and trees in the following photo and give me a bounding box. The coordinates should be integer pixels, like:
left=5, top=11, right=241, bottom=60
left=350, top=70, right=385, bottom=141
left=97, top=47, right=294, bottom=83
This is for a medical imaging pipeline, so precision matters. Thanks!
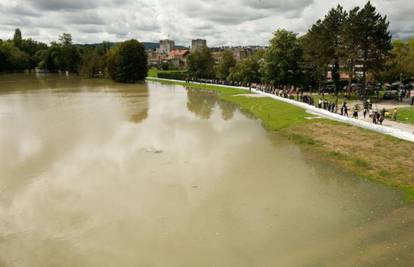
left=0, top=74, right=414, bottom=267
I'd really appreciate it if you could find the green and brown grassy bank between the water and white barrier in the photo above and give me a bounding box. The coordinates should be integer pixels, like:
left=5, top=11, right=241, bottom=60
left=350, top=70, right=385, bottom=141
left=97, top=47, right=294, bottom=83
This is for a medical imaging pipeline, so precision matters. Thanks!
left=148, top=78, right=414, bottom=202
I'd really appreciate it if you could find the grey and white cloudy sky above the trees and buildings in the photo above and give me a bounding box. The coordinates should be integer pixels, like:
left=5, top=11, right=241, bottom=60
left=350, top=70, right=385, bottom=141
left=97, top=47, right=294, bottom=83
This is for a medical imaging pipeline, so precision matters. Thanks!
left=0, top=0, right=414, bottom=46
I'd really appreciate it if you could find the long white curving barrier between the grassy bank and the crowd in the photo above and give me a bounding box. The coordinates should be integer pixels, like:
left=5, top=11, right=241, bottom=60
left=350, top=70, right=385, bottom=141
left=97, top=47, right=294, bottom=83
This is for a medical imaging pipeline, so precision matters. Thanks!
left=147, top=77, right=414, bottom=143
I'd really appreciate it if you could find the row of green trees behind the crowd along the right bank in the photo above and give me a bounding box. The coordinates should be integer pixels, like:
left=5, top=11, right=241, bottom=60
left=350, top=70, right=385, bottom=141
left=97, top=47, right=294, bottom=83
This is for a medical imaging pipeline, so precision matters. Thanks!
left=188, top=2, right=396, bottom=92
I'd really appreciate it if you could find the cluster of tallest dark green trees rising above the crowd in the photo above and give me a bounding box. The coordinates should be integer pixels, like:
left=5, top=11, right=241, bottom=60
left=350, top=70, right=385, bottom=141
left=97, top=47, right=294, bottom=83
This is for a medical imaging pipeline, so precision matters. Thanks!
left=302, top=2, right=392, bottom=90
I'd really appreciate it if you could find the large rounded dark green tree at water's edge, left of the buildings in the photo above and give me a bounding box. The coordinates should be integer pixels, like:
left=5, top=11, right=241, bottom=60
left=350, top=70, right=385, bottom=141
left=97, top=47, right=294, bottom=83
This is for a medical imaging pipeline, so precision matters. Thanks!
left=108, top=39, right=148, bottom=83
